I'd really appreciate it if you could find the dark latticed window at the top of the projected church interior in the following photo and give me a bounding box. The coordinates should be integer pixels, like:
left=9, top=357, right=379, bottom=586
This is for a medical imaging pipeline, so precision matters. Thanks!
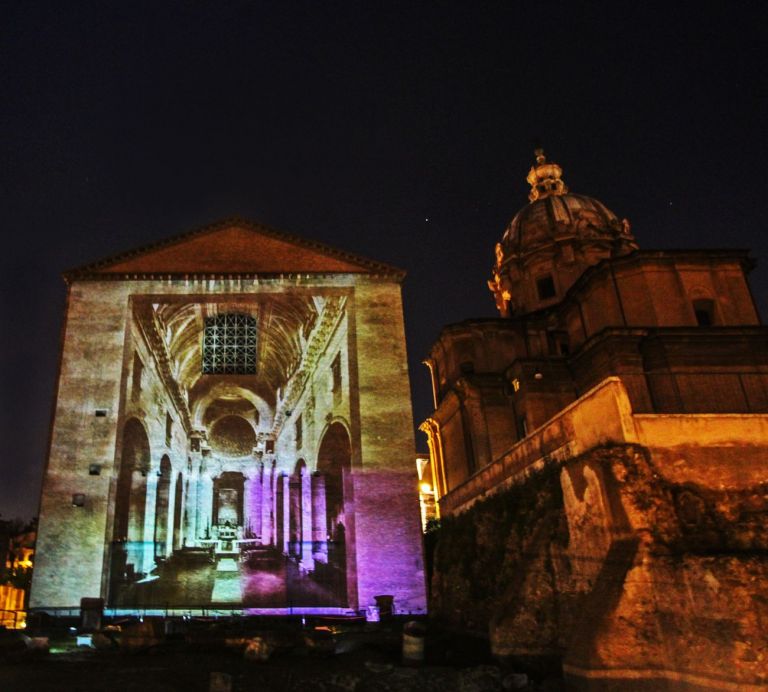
left=203, top=313, right=256, bottom=375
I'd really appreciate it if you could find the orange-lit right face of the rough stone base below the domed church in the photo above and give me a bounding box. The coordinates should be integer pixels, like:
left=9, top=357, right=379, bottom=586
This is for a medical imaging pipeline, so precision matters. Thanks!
left=565, top=446, right=768, bottom=689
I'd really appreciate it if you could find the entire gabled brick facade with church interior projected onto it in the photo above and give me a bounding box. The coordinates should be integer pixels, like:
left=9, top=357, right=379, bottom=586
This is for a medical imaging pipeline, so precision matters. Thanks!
left=32, top=222, right=425, bottom=612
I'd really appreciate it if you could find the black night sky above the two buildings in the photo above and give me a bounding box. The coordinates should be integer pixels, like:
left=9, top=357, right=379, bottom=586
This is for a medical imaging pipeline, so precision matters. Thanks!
left=0, top=0, right=768, bottom=517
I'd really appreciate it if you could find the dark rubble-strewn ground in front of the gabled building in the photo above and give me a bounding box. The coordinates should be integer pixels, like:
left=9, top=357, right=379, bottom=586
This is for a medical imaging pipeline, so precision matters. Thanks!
left=0, top=618, right=563, bottom=692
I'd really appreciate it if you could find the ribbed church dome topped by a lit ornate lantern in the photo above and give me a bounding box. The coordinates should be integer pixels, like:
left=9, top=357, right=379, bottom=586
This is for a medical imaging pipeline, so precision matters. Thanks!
left=488, top=149, right=637, bottom=316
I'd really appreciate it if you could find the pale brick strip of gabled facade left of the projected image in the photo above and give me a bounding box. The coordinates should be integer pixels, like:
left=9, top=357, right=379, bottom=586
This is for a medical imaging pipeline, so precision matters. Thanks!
left=30, top=282, right=128, bottom=607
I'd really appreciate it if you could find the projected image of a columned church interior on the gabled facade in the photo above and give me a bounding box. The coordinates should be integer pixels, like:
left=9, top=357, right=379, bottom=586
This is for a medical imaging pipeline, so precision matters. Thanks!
left=110, top=294, right=351, bottom=607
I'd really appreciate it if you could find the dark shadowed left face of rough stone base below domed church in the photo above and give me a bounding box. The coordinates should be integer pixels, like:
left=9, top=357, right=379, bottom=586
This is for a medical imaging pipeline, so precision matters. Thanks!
left=429, top=468, right=568, bottom=655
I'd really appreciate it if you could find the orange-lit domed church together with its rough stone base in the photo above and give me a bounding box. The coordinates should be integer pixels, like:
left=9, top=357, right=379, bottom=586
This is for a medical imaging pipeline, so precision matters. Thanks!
left=421, top=150, right=768, bottom=689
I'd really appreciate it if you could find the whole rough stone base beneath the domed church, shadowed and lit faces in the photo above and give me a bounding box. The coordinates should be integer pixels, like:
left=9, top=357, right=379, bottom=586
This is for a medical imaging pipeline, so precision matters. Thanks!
left=430, top=444, right=768, bottom=689
